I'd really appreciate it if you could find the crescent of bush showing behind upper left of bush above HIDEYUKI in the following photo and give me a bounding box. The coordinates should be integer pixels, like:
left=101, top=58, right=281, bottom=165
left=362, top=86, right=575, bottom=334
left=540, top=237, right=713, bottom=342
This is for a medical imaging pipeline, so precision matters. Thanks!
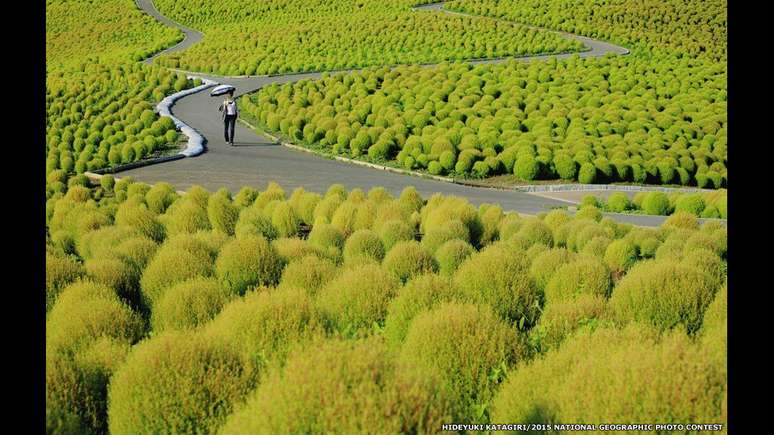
left=384, top=273, right=459, bottom=346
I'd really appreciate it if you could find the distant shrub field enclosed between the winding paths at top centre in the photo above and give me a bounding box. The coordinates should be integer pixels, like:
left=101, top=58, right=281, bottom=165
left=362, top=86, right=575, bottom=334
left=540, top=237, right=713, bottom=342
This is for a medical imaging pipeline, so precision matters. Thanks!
left=156, top=0, right=584, bottom=75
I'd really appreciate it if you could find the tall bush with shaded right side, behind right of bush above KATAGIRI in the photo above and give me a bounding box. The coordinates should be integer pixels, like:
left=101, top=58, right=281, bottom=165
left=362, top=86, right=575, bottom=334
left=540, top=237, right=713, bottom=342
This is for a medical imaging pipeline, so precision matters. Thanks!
left=454, top=243, right=540, bottom=328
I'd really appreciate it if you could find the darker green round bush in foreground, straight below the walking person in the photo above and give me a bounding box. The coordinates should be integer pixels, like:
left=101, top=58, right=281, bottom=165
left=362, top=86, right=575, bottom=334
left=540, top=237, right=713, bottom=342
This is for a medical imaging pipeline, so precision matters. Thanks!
left=215, top=236, right=285, bottom=295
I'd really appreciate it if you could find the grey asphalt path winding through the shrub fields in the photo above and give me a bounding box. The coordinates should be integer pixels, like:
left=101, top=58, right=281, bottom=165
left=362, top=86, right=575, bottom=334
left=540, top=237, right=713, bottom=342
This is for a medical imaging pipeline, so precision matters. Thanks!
left=122, top=0, right=688, bottom=226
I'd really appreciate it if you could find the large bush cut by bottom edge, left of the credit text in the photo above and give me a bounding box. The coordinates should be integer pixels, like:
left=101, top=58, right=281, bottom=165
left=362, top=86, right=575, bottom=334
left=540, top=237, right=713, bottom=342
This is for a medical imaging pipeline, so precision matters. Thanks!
left=220, top=338, right=453, bottom=435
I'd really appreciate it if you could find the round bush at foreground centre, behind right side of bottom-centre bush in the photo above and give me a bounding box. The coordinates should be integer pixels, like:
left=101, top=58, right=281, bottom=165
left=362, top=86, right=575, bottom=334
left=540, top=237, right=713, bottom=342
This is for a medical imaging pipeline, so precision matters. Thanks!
left=317, top=264, right=399, bottom=336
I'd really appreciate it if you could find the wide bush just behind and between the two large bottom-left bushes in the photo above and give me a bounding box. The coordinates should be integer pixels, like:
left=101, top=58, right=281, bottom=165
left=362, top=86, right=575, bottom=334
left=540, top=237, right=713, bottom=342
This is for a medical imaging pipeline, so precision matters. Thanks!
left=204, top=287, right=324, bottom=366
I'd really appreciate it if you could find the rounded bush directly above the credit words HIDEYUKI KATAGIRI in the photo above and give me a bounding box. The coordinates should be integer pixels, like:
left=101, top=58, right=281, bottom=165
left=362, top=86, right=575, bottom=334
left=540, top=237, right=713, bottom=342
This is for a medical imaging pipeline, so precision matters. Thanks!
left=400, top=303, right=527, bottom=422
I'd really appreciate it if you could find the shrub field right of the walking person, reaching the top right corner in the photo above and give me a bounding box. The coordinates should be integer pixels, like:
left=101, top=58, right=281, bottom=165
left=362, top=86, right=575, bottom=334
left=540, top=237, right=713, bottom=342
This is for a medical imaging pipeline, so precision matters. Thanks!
left=245, top=0, right=728, bottom=189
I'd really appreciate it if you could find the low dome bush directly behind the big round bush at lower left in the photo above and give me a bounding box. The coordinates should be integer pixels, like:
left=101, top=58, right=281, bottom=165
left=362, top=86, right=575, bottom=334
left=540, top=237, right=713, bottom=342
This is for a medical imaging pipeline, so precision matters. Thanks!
left=151, top=277, right=233, bottom=333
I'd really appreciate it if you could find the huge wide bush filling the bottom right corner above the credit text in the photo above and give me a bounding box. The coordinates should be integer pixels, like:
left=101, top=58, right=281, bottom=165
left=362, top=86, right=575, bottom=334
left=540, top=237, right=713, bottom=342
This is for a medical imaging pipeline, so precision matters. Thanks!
left=492, top=325, right=727, bottom=424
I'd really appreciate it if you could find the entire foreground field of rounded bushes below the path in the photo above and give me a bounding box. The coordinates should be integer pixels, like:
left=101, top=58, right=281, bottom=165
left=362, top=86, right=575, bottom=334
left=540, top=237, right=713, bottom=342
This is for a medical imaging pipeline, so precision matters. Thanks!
left=46, top=176, right=727, bottom=434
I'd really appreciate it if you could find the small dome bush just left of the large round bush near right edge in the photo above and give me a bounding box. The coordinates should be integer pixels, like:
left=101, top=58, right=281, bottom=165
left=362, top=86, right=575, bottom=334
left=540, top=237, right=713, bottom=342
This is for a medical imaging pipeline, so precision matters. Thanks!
left=545, top=256, right=611, bottom=304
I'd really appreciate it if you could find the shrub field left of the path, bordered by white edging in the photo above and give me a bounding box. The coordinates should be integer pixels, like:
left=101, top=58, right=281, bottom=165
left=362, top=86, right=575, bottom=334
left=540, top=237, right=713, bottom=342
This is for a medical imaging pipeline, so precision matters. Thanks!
left=46, top=0, right=199, bottom=177
